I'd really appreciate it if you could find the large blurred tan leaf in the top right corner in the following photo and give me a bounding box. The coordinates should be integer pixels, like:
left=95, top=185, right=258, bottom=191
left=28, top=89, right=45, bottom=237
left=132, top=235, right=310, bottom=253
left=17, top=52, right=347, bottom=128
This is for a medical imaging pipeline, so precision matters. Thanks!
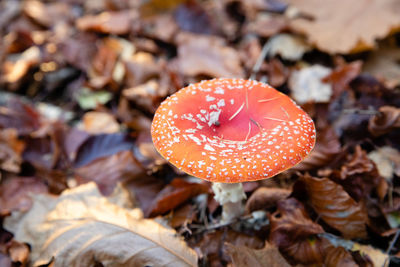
left=285, top=0, right=400, bottom=53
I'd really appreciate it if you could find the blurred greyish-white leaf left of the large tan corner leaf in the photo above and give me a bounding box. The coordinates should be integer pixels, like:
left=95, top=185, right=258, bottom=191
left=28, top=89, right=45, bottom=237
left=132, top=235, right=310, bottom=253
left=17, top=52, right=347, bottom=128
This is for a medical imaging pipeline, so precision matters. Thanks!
left=266, top=33, right=311, bottom=61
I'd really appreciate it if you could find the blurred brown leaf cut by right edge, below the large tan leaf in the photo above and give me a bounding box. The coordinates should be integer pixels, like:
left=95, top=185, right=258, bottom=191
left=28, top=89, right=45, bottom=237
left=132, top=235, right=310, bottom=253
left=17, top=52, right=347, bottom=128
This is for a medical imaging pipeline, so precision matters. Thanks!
left=363, top=47, right=400, bottom=88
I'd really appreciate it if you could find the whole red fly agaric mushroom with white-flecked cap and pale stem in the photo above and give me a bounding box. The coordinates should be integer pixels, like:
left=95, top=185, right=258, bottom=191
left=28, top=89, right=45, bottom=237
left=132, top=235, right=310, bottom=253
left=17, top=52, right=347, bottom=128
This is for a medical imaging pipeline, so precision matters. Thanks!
left=151, top=79, right=315, bottom=222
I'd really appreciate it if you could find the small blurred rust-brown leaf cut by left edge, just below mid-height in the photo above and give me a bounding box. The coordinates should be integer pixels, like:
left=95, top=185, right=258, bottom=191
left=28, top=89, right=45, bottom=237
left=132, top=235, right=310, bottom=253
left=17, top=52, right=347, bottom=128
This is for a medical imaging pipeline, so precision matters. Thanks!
left=0, top=128, right=25, bottom=173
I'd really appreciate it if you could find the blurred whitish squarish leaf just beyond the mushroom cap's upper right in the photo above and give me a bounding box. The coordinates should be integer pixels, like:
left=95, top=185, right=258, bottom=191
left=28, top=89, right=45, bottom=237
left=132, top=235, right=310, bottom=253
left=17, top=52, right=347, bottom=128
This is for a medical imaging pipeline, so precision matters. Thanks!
left=289, top=65, right=332, bottom=105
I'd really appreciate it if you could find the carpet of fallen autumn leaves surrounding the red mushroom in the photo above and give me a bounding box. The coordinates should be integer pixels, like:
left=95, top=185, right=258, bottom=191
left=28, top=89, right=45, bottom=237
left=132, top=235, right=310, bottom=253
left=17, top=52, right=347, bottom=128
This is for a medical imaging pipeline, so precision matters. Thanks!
left=0, top=0, right=400, bottom=266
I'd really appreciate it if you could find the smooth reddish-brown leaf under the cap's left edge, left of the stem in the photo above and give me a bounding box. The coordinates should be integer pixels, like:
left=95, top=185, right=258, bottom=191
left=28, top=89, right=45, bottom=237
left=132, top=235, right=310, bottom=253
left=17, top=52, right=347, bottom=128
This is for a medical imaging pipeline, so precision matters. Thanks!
left=147, top=178, right=209, bottom=217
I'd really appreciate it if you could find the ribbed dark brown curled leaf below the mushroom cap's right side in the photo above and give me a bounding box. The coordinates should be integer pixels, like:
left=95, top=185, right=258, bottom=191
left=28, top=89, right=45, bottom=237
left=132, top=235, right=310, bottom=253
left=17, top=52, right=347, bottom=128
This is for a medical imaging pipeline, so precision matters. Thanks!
left=301, top=174, right=368, bottom=239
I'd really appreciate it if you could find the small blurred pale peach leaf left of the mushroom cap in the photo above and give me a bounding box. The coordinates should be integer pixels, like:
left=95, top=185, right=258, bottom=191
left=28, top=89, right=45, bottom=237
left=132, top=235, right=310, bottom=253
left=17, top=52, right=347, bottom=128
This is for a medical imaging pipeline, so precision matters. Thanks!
left=82, top=111, right=120, bottom=134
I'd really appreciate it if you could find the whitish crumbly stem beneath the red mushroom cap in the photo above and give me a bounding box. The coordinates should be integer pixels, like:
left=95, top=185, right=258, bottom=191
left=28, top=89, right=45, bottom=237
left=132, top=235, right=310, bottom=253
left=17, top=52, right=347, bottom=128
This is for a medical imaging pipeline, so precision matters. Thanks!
left=212, top=183, right=246, bottom=223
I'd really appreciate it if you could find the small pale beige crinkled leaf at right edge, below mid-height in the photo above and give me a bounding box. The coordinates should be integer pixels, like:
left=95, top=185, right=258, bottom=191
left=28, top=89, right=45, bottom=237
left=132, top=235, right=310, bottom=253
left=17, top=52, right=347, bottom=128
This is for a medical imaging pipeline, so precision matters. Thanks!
left=368, top=146, right=400, bottom=181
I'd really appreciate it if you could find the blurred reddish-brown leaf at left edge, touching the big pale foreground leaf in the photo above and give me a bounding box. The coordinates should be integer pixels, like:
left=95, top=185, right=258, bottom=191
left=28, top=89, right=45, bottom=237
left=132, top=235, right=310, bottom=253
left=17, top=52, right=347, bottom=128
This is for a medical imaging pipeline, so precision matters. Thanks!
left=0, top=177, right=47, bottom=214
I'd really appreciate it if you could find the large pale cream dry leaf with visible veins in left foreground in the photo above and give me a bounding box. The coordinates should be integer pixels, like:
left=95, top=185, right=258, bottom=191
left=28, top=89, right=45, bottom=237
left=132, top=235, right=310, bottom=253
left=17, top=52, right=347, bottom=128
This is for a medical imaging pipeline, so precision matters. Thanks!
left=5, top=183, right=197, bottom=266
